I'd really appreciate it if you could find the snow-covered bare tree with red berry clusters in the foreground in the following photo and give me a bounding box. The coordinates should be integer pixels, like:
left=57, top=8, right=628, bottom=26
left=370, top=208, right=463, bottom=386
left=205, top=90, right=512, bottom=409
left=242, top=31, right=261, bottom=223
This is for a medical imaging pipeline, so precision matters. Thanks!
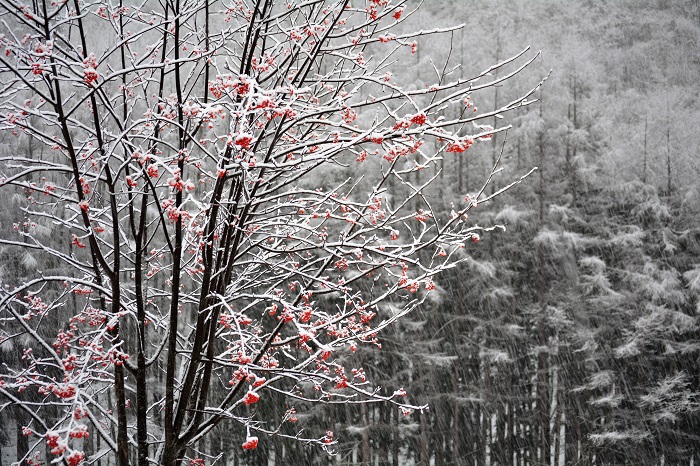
left=0, top=0, right=539, bottom=465
